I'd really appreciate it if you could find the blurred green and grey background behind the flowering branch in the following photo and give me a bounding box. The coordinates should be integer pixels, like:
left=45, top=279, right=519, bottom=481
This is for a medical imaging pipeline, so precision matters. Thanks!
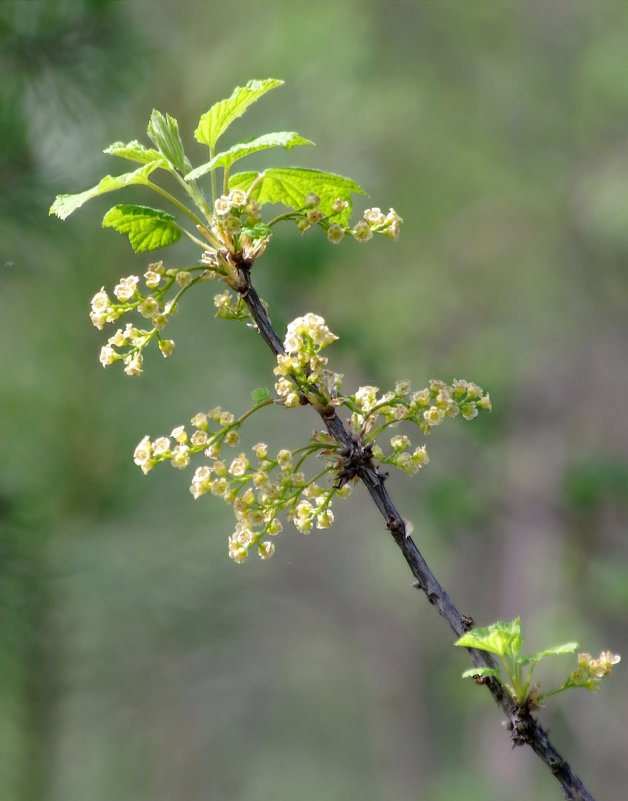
left=0, top=0, right=628, bottom=801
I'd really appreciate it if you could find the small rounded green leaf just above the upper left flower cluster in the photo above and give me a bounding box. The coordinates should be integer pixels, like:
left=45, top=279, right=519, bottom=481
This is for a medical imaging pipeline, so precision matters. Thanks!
left=102, top=203, right=181, bottom=253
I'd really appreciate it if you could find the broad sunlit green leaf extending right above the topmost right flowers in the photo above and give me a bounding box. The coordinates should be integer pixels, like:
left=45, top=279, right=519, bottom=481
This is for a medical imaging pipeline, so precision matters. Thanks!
left=229, top=167, right=366, bottom=223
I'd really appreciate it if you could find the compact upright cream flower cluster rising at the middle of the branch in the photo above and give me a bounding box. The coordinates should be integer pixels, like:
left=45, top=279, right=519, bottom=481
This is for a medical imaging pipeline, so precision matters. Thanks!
left=274, top=313, right=342, bottom=407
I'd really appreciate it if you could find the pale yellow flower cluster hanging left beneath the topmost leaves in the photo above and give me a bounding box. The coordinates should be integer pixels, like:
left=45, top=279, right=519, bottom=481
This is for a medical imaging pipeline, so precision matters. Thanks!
left=89, top=262, right=208, bottom=375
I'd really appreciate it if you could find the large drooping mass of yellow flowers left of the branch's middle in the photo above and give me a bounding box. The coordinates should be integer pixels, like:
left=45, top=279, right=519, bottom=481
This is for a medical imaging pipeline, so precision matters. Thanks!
left=134, top=400, right=351, bottom=563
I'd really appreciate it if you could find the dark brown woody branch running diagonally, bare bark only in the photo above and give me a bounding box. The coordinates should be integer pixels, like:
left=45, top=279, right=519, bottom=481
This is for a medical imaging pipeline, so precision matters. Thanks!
left=239, top=265, right=594, bottom=801
